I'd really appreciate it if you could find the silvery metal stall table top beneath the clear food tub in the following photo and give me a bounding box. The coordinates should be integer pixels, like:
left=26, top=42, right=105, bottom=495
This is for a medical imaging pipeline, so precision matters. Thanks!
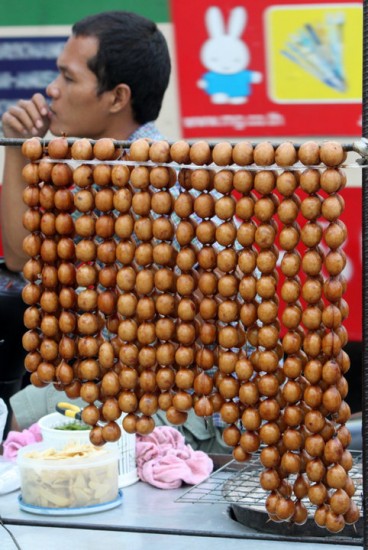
left=0, top=482, right=362, bottom=550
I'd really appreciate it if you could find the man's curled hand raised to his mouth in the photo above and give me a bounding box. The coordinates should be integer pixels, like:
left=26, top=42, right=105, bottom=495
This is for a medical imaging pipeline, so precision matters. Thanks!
left=2, top=94, right=50, bottom=138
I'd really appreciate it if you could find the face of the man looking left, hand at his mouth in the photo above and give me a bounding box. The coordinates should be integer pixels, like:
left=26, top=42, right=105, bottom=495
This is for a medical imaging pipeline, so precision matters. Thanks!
left=46, top=36, right=110, bottom=139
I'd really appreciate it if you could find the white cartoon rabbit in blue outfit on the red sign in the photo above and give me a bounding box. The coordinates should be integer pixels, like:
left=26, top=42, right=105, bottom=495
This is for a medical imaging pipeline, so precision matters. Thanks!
left=197, top=6, right=262, bottom=104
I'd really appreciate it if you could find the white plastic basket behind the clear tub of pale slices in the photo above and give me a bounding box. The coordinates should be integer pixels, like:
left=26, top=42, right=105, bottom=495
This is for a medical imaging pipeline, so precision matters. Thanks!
left=38, top=412, right=139, bottom=487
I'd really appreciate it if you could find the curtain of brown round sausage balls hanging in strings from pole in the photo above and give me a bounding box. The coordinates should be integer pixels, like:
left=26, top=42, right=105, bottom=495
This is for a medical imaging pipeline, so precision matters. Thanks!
left=22, top=137, right=359, bottom=532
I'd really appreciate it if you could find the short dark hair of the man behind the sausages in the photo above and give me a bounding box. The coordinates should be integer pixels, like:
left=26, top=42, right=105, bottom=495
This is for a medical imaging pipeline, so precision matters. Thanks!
left=72, top=11, right=171, bottom=124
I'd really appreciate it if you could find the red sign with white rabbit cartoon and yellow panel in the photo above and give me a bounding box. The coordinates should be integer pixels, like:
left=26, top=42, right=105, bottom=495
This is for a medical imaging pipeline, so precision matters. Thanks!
left=171, top=0, right=362, bottom=138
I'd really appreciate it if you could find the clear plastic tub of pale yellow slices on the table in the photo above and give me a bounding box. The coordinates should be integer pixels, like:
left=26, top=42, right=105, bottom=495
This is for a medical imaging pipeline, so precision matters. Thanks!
left=17, top=442, right=119, bottom=508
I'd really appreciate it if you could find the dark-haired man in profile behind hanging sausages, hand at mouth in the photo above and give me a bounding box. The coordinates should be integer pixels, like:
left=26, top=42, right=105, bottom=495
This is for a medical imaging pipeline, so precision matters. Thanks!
left=1, top=11, right=171, bottom=271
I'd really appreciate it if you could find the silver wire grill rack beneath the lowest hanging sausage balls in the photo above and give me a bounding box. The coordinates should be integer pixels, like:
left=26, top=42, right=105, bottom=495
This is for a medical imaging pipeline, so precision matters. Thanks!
left=176, top=451, right=363, bottom=516
